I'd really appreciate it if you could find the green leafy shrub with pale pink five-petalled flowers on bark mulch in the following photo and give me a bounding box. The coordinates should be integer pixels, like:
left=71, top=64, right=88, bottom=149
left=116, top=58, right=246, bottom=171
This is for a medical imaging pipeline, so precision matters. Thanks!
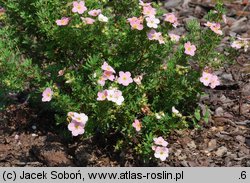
left=1, top=0, right=229, bottom=161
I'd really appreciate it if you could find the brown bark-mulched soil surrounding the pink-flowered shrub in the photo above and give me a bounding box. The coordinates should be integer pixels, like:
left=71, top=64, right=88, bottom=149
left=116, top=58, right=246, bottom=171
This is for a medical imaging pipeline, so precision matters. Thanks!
left=0, top=0, right=250, bottom=167
